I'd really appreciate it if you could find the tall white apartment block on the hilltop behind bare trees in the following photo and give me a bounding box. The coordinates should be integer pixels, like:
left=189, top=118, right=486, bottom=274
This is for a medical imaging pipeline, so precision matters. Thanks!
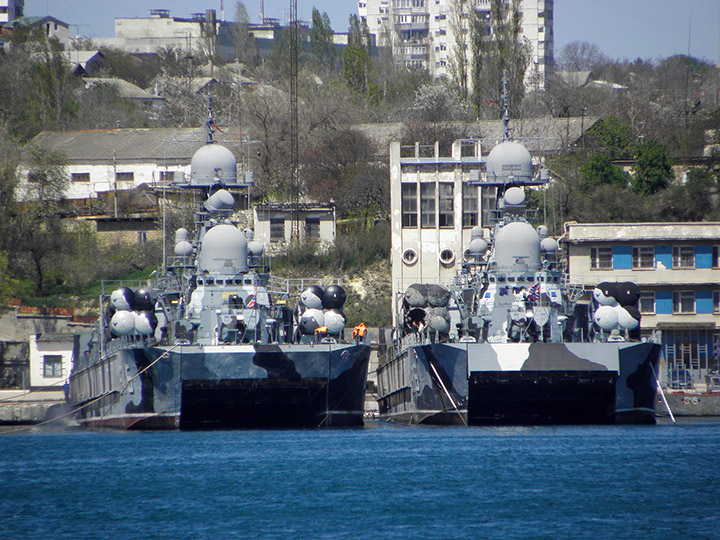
left=358, top=0, right=553, bottom=85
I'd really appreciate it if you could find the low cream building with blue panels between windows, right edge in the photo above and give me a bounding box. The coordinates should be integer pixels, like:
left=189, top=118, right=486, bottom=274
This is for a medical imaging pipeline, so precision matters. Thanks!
left=563, top=223, right=720, bottom=388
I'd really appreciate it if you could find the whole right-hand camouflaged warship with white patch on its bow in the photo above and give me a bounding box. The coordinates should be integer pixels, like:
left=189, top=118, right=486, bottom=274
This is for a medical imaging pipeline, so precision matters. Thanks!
left=377, top=103, right=661, bottom=425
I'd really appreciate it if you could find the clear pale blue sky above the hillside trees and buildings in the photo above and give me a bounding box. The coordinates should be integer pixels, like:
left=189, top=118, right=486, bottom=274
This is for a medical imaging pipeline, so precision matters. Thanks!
left=25, top=0, right=720, bottom=63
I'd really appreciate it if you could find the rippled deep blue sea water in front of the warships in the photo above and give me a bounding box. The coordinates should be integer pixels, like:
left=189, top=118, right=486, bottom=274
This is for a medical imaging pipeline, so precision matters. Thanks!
left=0, top=421, right=720, bottom=540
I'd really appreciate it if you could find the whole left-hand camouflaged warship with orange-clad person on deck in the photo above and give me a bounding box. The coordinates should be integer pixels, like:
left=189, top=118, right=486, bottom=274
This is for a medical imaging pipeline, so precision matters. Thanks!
left=68, top=109, right=370, bottom=429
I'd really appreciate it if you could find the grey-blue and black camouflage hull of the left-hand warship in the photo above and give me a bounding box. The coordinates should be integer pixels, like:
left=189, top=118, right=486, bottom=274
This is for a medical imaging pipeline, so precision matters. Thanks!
left=70, top=344, right=370, bottom=429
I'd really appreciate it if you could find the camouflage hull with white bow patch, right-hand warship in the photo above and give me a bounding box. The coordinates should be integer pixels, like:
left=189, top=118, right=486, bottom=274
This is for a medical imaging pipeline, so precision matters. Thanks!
left=378, top=342, right=660, bottom=425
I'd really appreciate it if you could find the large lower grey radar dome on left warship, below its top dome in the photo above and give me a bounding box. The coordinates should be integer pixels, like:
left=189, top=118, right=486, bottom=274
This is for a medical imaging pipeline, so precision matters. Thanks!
left=198, top=223, right=248, bottom=275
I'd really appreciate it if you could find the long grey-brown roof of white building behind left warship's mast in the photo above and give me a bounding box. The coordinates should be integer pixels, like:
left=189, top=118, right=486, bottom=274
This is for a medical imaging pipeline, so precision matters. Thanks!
left=26, top=127, right=250, bottom=165
